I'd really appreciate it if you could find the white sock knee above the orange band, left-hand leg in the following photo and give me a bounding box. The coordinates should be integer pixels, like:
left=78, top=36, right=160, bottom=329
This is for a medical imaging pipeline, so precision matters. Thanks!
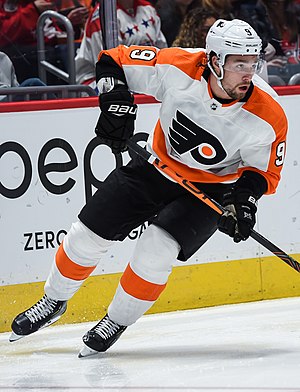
left=63, top=221, right=114, bottom=266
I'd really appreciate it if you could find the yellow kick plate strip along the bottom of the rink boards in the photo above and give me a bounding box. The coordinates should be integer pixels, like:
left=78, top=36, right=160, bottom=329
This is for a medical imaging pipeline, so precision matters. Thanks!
left=0, top=254, right=300, bottom=332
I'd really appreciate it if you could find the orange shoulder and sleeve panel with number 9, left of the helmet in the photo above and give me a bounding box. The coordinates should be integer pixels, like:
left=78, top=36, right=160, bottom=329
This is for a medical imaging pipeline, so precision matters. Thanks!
left=98, top=45, right=207, bottom=80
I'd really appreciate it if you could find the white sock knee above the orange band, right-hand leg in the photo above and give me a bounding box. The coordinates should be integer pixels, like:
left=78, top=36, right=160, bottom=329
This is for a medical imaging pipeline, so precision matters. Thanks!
left=130, top=225, right=180, bottom=284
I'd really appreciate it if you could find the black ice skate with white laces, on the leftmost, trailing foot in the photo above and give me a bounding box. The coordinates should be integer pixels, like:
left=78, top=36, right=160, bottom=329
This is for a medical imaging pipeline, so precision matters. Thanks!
left=9, top=294, right=67, bottom=342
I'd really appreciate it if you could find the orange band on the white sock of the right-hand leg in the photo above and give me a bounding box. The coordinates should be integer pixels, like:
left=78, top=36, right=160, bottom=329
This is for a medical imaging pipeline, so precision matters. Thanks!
left=120, top=264, right=166, bottom=301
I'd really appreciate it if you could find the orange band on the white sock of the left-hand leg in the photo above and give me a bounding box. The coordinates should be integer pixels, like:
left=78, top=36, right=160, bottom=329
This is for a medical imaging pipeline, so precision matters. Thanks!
left=55, top=243, right=96, bottom=280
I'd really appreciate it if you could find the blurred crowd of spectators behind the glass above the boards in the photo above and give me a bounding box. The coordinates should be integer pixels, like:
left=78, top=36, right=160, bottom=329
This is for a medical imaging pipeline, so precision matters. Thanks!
left=0, top=0, right=300, bottom=99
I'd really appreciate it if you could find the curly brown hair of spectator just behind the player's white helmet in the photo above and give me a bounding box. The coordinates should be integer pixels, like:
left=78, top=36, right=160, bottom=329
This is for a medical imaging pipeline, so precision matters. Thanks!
left=172, top=7, right=218, bottom=48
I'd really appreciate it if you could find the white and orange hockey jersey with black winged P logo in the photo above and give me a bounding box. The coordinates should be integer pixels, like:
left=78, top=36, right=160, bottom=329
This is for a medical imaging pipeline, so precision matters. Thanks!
left=99, top=46, right=287, bottom=193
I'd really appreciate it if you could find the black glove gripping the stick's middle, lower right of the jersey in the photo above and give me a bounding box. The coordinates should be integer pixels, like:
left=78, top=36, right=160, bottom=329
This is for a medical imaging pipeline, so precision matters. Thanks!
left=218, top=187, right=257, bottom=242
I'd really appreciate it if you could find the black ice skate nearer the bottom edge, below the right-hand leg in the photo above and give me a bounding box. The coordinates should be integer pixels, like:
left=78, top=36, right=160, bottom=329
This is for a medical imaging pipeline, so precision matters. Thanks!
left=78, top=314, right=127, bottom=358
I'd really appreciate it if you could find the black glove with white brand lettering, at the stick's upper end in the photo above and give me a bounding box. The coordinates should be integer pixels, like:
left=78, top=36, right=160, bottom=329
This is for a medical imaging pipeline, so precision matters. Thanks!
left=95, top=86, right=137, bottom=154
